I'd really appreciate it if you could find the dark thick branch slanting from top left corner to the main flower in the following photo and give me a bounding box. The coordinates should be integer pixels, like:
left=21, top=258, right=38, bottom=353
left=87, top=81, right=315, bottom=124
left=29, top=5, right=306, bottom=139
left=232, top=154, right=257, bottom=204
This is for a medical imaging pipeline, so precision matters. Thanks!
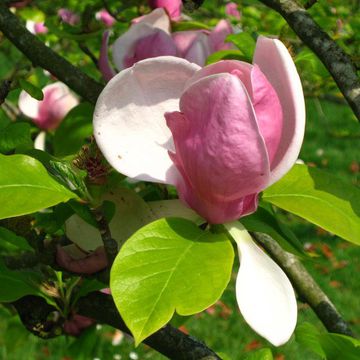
left=0, top=0, right=103, bottom=104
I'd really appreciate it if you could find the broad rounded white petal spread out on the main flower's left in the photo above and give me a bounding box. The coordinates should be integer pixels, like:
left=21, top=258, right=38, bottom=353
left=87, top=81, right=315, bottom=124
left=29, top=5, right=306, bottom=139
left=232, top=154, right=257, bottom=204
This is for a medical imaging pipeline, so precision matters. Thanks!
left=94, top=56, right=200, bottom=184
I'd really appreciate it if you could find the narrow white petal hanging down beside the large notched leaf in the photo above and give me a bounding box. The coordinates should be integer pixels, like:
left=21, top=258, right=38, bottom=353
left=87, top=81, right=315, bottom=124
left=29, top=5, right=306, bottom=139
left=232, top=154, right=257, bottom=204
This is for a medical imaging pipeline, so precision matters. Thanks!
left=225, top=222, right=297, bottom=346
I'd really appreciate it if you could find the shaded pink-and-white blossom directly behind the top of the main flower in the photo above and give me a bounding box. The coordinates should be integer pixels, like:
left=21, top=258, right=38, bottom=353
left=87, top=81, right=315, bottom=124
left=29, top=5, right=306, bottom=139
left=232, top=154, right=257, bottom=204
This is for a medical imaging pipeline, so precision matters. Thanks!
left=99, top=8, right=232, bottom=80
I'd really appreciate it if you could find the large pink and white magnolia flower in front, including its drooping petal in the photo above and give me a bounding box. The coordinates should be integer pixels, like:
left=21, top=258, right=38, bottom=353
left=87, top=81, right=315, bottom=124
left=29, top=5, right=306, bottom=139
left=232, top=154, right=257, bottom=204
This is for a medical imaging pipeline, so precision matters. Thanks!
left=94, top=37, right=305, bottom=345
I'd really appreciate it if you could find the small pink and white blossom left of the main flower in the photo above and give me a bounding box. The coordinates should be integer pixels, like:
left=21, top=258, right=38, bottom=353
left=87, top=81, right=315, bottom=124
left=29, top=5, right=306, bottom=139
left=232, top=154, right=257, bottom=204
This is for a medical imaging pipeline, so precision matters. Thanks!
left=19, top=82, right=78, bottom=130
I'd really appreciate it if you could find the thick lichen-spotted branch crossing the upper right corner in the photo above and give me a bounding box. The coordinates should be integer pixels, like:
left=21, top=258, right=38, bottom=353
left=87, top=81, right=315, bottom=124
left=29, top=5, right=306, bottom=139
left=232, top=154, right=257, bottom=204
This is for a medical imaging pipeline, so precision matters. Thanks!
left=260, top=0, right=360, bottom=120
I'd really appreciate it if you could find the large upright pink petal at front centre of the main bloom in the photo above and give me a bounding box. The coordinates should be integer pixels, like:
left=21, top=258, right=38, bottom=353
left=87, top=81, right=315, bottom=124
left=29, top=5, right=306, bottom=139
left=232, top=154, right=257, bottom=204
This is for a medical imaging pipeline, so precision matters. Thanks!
left=165, top=74, right=269, bottom=223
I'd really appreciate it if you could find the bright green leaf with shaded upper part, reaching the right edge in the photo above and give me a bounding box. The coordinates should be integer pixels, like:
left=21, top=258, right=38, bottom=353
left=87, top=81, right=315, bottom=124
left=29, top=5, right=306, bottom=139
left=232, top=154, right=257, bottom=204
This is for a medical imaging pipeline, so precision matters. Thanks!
left=262, top=165, right=360, bottom=244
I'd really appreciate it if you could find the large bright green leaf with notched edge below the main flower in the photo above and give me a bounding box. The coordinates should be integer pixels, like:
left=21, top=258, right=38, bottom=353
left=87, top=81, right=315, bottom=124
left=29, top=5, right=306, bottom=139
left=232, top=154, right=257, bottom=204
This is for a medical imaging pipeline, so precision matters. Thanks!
left=110, top=218, right=234, bottom=344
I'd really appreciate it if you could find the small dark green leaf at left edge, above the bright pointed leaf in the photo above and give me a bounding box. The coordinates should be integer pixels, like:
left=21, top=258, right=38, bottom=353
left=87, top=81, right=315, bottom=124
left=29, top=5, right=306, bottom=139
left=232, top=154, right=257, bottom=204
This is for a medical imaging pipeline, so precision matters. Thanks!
left=0, top=123, right=32, bottom=153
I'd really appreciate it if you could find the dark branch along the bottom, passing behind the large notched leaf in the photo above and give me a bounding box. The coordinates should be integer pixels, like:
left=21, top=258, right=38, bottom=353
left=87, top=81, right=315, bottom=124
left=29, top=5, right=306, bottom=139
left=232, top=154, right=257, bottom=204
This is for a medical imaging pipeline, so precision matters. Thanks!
left=13, top=292, right=221, bottom=360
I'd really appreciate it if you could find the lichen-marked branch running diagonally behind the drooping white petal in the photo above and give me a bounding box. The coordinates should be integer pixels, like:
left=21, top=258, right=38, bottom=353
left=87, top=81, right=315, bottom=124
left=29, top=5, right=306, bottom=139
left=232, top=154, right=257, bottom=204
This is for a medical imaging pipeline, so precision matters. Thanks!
left=252, top=232, right=353, bottom=336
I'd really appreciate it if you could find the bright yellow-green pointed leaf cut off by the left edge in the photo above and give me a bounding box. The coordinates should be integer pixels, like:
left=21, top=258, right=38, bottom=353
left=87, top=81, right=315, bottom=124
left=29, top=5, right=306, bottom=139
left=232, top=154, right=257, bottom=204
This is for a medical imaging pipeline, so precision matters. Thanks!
left=0, top=155, right=76, bottom=219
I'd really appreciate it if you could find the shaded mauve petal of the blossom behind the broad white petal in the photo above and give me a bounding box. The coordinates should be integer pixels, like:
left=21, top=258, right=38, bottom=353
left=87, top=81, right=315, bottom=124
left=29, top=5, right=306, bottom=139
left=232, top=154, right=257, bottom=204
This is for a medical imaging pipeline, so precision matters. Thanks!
left=124, top=29, right=176, bottom=67
